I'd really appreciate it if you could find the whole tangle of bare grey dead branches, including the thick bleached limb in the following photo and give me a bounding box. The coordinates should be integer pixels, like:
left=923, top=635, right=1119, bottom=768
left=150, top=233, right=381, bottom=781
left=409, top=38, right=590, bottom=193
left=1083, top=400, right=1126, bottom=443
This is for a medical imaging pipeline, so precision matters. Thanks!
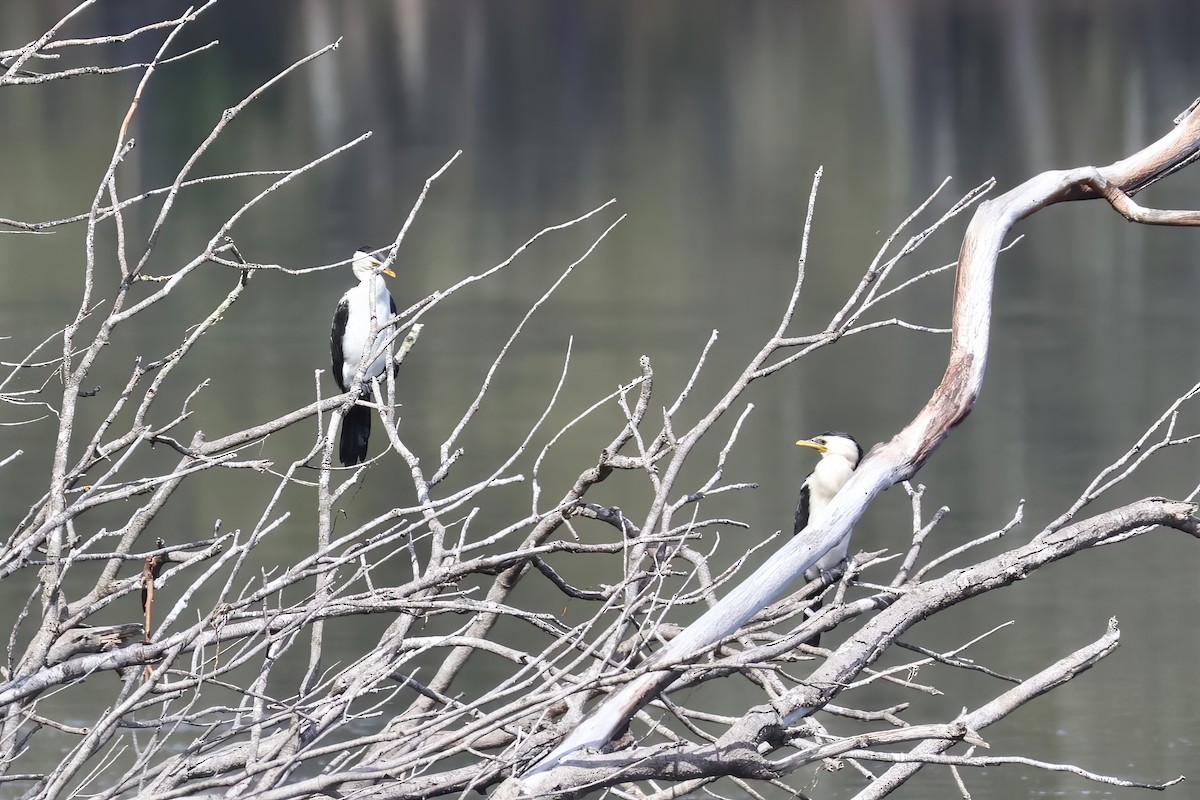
left=0, top=6, right=1200, bottom=800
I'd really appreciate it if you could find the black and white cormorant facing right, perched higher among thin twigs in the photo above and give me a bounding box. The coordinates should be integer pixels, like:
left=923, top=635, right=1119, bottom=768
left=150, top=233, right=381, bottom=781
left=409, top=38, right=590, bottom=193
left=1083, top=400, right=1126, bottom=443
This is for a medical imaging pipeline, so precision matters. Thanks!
left=329, top=247, right=396, bottom=467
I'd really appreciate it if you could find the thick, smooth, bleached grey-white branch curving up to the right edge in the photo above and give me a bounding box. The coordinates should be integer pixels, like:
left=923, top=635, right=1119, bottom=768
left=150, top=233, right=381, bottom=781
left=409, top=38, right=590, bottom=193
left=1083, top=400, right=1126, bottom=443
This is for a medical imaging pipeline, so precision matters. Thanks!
left=504, top=97, right=1200, bottom=796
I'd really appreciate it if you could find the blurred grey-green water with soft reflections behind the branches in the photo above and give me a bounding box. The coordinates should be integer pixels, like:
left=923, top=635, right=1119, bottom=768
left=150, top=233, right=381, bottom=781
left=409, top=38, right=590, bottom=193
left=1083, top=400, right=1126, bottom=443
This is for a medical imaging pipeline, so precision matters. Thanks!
left=0, top=0, right=1200, bottom=799
